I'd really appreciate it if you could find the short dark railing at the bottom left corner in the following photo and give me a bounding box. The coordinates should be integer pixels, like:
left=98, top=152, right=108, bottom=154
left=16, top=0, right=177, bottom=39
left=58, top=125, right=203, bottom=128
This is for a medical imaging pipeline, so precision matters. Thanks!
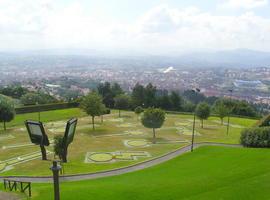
left=4, top=179, right=32, bottom=197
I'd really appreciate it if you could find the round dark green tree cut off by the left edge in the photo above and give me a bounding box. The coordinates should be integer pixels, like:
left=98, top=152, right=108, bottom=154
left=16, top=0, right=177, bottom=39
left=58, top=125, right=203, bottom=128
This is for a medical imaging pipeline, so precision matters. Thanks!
left=0, top=100, right=15, bottom=130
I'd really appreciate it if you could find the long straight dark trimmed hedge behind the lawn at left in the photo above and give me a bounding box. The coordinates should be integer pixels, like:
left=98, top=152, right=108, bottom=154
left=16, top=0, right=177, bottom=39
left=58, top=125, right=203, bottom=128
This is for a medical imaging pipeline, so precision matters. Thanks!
left=15, top=102, right=79, bottom=114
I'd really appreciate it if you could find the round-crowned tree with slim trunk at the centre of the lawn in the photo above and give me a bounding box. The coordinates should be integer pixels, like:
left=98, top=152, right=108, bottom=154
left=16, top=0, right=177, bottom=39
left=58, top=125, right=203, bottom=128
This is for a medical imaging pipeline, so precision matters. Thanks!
left=141, top=108, right=165, bottom=144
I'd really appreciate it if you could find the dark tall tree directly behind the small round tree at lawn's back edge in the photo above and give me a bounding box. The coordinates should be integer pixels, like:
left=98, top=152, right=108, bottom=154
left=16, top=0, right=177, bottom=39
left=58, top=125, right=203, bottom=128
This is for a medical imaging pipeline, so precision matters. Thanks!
left=131, top=83, right=145, bottom=108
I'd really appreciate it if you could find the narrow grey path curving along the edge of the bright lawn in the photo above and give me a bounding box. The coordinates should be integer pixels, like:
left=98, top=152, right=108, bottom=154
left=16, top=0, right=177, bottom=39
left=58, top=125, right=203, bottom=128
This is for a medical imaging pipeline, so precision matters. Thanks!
left=0, top=142, right=242, bottom=183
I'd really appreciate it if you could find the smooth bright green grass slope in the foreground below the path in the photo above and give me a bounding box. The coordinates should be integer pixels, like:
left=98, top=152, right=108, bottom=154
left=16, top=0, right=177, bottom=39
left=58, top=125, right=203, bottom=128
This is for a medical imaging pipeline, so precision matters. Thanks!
left=25, top=147, right=270, bottom=200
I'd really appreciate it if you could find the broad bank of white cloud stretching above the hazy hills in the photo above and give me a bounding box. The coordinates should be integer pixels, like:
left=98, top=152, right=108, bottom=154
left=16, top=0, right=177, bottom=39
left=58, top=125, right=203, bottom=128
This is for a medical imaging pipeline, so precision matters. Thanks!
left=0, top=0, right=270, bottom=53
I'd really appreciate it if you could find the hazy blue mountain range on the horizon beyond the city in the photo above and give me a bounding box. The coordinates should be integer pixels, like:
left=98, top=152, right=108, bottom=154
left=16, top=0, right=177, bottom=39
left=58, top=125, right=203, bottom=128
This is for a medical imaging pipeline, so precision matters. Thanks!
left=0, top=49, right=270, bottom=69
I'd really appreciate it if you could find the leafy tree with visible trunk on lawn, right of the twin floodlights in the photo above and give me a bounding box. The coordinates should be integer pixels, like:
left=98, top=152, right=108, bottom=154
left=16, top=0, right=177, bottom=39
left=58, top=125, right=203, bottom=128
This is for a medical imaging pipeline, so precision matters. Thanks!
left=81, top=92, right=104, bottom=130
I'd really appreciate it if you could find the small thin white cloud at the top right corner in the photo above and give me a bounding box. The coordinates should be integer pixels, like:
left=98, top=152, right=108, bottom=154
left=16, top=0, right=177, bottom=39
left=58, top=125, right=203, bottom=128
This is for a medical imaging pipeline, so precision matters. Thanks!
left=221, top=0, right=268, bottom=9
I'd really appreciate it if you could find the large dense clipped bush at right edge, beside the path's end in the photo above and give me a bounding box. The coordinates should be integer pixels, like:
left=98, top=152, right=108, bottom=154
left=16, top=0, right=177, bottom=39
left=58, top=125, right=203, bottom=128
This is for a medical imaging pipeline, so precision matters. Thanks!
left=240, top=127, right=270, bottom=148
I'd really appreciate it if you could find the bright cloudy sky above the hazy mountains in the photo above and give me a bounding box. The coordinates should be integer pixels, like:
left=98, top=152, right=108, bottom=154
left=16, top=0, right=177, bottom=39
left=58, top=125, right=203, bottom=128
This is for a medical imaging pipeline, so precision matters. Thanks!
left=0, top=0, right=270, bottom=54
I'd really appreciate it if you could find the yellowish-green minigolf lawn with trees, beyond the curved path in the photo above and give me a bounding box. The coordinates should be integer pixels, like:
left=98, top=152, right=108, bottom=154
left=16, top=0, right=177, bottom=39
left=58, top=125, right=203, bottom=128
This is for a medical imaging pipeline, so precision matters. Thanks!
left=0, top=108, right=256, bottom=176
